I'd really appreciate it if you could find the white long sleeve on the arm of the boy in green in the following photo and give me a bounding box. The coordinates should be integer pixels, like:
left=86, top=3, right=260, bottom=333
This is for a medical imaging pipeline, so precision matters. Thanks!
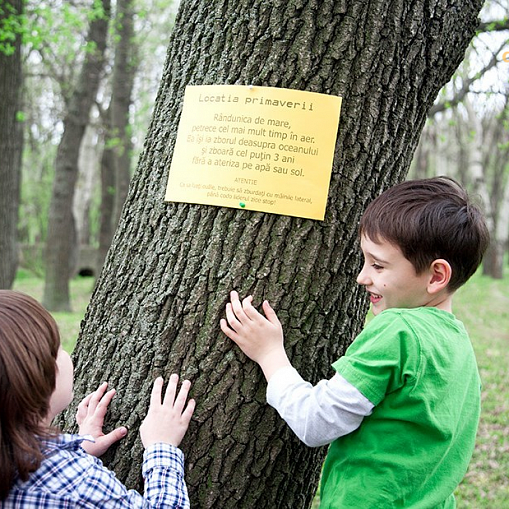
left=267, top=367, right=374, bottom=447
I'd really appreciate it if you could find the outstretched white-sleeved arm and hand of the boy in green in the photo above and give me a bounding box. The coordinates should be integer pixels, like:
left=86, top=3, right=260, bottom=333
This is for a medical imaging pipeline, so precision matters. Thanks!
left=221, top=291, right=373, bottom=447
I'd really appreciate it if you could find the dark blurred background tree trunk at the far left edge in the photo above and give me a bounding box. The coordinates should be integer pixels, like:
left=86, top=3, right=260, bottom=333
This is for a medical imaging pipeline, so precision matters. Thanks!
left=0, top=0, right=23, bottom=288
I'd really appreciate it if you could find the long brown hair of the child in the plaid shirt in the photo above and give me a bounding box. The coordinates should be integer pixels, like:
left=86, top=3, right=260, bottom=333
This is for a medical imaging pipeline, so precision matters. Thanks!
left=0, top=290, right=60, bottom=501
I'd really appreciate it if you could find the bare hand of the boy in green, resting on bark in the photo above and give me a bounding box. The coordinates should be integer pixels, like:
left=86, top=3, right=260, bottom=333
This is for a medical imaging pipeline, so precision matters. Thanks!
left=221, top=291, right=291, bottom=381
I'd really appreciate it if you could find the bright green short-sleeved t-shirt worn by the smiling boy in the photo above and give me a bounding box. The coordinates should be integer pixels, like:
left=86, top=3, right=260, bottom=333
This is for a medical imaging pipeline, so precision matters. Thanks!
left=320, top=307, right=481, bottom=509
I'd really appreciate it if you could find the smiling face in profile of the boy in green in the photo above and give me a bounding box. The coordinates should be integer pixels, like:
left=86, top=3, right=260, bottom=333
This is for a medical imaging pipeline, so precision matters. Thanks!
left=357, top=235, right=434, bottom=315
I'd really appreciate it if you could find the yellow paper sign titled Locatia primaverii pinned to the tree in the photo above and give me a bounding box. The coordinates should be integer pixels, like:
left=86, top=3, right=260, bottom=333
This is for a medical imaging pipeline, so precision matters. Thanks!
left=165, top=85, right=341, bottom=219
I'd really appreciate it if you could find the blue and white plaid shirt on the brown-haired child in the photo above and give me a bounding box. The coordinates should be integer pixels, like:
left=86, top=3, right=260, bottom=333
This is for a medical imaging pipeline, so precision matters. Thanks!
left=0, top=434, right=189, bottom=509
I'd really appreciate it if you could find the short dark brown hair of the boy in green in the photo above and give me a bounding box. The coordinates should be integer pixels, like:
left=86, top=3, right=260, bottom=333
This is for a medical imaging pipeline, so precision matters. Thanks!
left=359, top=177, right=489, bottom=292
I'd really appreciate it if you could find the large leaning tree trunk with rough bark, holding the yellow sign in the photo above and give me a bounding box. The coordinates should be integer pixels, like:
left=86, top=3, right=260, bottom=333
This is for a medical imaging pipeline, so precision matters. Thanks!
left=62, top=0, right=482, bottom=509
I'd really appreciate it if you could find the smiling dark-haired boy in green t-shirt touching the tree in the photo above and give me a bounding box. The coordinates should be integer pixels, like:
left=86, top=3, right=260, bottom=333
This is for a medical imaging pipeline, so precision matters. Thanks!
left=221, top=177, right=489, bottom=509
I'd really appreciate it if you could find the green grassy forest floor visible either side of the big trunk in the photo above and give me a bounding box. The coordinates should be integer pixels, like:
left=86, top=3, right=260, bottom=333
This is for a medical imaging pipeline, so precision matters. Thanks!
left=14, top=270, right=509, bottom=509
